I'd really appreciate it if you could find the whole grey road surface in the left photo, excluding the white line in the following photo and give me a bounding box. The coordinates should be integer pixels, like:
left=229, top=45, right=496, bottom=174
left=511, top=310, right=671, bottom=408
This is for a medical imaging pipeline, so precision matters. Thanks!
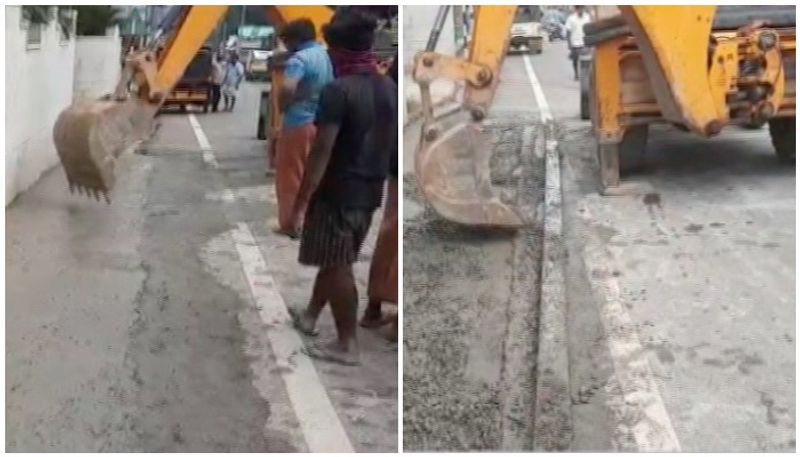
left=5, top=84, right=397, bottom=452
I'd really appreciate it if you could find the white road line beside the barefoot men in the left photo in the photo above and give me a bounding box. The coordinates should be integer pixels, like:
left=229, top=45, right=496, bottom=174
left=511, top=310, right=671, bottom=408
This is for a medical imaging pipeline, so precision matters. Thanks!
left=189, top=114, right=354, bottom=452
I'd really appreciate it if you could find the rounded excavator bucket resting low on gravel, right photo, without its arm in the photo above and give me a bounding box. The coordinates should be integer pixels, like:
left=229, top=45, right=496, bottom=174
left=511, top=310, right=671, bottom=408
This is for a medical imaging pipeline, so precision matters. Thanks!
left=414, top=122, right=524, bottom=228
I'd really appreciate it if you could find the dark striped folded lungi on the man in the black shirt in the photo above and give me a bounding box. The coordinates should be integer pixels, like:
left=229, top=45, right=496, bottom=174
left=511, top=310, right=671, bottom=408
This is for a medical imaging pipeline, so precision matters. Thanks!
left=299, top=198, right=374, bottom=267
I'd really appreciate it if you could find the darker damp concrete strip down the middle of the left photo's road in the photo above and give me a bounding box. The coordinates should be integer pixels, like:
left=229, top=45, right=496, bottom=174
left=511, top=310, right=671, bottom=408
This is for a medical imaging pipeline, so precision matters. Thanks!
left=126, top=157, right=296, bottom=452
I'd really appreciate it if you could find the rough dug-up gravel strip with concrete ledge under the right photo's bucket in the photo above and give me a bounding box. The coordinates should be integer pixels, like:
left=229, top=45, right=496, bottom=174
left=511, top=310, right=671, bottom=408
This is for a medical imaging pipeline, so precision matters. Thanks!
left=403, top=112, right=545, bottom=451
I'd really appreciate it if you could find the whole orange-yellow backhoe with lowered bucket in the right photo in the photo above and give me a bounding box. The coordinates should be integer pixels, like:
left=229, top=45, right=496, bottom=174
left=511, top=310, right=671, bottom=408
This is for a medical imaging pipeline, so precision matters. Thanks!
left=413, top=5, right=796, bottom=228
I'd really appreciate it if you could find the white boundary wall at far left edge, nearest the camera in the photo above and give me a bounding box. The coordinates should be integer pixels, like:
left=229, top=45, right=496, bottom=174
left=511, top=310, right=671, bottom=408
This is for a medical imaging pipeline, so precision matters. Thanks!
left=4, top=6, right=75, bottom=205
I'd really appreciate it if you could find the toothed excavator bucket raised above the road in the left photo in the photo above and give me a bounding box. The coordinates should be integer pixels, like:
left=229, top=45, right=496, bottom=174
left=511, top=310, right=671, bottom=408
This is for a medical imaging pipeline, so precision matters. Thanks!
left=53, top=98, right=157, bottom=202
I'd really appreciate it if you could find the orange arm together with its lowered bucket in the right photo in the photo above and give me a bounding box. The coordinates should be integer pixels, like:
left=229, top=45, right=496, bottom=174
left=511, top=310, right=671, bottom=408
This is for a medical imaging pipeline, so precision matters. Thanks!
left=413, top=5, right=525, bottom=228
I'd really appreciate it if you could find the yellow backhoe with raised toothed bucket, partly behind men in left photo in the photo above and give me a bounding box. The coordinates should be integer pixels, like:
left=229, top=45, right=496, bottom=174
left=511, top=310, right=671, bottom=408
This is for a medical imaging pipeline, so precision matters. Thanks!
left=53, top=5, right=396, bottom=202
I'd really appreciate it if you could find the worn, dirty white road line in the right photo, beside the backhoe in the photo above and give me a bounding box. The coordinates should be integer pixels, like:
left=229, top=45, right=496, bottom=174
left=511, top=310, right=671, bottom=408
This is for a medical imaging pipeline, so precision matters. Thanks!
left=523, top=55, right=680, bottom=452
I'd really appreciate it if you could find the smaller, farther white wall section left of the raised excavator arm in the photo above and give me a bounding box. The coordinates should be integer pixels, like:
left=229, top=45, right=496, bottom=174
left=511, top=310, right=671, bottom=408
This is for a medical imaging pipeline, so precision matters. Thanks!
left=73, top=27, right=122, bottom=100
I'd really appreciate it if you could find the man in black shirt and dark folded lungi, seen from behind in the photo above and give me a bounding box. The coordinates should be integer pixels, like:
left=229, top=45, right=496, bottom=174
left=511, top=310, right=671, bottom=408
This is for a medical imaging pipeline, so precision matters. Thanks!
left=292, top=8, right=398, bottom=365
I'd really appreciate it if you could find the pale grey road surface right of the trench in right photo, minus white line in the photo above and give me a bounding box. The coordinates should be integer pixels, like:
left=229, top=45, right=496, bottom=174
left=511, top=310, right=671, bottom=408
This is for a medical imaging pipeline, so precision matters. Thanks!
left=533, top=39, right=796, bottom=452
